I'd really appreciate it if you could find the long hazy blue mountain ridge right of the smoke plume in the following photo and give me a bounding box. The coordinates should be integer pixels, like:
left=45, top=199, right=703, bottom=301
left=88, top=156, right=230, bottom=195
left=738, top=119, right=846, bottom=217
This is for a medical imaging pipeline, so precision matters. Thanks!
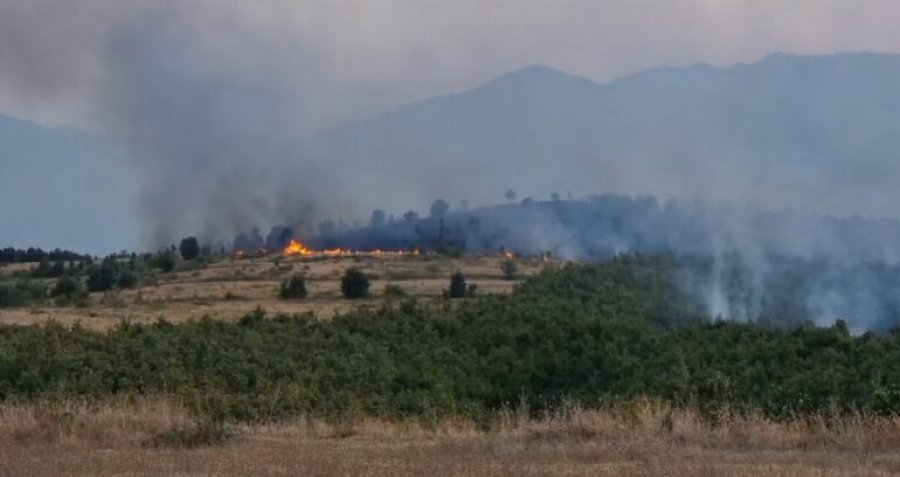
left=309, top=53, right=900, bottom=216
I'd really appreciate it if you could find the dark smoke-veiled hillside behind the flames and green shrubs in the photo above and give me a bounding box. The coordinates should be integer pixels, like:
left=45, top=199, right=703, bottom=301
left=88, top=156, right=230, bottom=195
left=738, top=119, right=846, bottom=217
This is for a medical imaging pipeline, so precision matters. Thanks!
left=294, top=194, right=900, bottom=332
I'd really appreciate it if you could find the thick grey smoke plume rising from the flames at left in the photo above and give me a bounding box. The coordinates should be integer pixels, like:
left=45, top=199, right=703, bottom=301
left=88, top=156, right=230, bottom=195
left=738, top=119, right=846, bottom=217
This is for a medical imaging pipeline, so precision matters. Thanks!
left=0, top=0, right=358, bottom=247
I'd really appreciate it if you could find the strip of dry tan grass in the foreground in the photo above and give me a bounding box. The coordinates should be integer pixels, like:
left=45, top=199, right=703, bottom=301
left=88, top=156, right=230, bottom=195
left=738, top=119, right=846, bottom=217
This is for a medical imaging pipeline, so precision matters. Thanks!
left=0, top=400, right=900, bottom=476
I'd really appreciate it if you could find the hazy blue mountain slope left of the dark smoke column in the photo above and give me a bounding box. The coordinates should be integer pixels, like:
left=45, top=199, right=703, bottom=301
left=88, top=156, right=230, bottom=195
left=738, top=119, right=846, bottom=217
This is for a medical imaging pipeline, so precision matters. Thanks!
left=0, top=115, right=140, bottom=254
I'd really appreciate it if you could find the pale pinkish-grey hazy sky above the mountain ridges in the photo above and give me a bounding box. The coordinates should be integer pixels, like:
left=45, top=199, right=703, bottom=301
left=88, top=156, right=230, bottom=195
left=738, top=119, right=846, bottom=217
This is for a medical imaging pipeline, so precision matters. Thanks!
left=0, top=0, right=900, bottom=129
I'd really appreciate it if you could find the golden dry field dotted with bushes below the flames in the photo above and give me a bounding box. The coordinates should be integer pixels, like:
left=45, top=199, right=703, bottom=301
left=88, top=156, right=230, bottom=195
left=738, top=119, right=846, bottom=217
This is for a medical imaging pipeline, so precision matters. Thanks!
left=0, top=254, right=546, bottom=329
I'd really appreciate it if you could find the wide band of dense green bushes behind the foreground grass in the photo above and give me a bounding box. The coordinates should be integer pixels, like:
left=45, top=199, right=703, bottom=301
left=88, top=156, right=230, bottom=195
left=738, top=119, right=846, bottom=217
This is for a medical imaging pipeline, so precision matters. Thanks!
left=0, top=256, right=900, bottom=422
